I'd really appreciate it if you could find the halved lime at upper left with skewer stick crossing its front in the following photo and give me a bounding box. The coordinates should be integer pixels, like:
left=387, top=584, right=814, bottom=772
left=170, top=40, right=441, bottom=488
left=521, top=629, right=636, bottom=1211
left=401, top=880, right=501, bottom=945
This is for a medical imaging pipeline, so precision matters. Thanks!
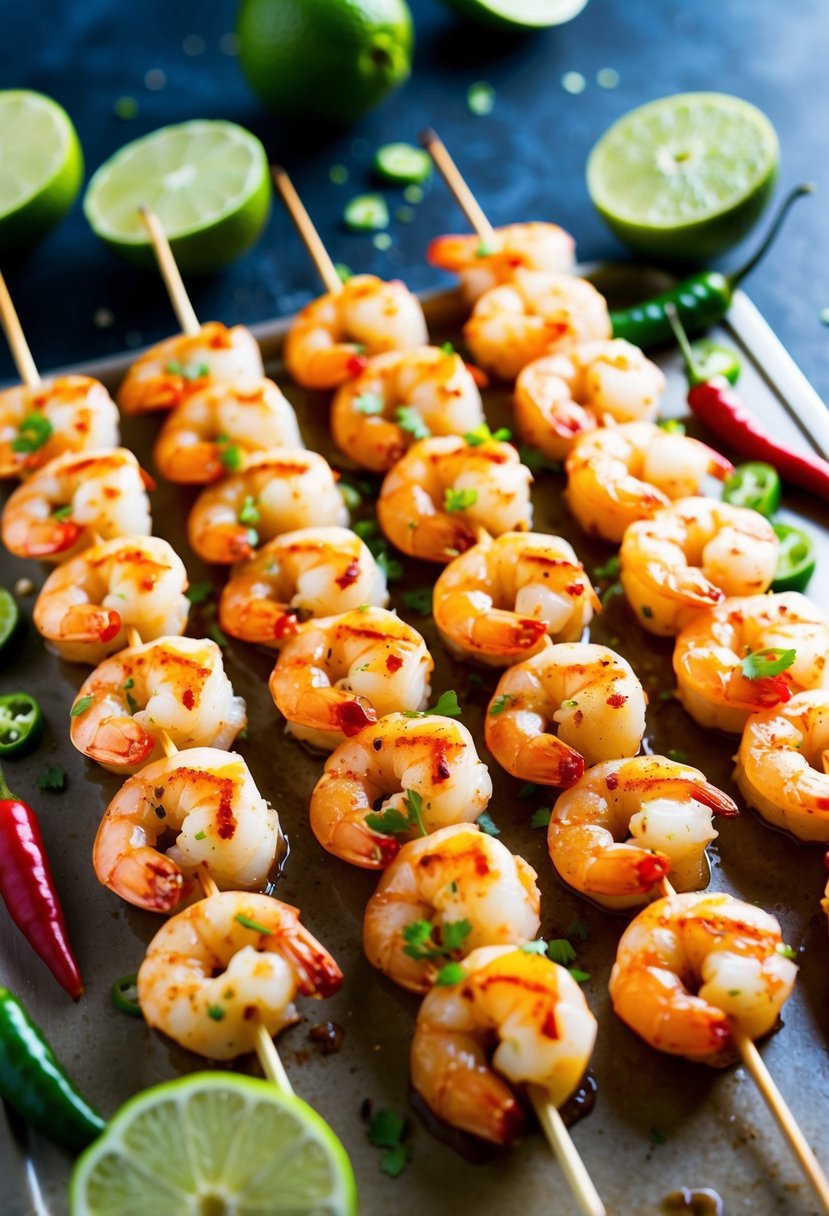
left=84, top=119, right=271, bottom=274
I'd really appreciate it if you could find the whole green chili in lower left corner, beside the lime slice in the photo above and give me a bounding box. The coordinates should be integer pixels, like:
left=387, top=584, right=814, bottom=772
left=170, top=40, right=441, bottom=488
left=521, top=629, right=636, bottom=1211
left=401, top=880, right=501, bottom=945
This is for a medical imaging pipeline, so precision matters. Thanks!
left=0, top=987, right=106, bottom=1149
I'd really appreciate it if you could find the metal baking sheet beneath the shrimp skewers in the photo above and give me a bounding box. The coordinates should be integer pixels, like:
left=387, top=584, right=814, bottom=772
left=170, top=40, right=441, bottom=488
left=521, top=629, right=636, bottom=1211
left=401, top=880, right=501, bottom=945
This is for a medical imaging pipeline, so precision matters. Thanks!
left=0, top=276, right=829, bottom=1216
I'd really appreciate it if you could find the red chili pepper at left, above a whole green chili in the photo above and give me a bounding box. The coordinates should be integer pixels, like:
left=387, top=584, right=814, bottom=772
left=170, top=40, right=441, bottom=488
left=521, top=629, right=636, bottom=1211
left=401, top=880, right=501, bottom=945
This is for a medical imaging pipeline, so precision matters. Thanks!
left=0, top=770, right=84, bottom=998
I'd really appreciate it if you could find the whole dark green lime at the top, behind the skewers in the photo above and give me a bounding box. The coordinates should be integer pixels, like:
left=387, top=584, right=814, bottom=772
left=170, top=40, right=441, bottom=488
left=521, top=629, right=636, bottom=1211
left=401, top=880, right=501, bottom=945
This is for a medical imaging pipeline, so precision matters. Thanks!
left=237, top=0, right=415, bottom=124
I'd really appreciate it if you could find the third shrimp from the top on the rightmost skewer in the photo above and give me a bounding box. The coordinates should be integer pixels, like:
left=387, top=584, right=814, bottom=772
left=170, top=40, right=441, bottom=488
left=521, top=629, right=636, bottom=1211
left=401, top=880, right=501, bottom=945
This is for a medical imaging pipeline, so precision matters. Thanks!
left=515, top=338, right=665, bottom=460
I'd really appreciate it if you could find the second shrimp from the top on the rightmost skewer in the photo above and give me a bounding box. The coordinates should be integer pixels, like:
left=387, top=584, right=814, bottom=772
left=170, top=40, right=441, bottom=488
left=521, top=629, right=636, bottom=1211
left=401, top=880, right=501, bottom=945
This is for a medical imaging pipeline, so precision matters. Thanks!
left=463, top=269, right=610, bottom=379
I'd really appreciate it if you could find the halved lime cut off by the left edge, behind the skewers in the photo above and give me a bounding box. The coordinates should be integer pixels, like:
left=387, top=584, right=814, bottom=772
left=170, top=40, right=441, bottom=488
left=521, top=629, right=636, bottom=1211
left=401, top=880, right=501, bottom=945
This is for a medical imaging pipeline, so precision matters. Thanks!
left=0, top=89, right=84, bottom=253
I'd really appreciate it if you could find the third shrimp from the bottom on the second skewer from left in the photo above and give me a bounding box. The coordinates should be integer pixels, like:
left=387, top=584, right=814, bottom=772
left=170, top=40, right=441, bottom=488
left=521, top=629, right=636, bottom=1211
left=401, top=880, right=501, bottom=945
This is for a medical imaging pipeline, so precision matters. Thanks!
left=311, top=714, right=492, bottom=869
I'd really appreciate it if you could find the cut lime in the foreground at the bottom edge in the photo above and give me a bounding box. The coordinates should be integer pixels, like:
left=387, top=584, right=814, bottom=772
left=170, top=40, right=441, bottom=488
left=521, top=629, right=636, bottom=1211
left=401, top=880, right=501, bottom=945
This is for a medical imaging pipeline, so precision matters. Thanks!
left=69, top=1073, right=356, bottom=1216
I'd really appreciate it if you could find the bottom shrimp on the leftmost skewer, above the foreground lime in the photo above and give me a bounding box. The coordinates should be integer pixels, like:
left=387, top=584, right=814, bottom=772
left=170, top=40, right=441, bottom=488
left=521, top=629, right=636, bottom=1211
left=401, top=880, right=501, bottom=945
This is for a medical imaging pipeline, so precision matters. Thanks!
left=137, top=891, right=343, bottom=1060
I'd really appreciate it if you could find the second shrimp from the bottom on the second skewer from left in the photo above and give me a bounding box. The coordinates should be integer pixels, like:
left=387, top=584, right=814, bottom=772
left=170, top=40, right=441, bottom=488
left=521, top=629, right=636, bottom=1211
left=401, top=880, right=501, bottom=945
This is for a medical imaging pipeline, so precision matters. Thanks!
left=362, top=823, right=541, bottom=992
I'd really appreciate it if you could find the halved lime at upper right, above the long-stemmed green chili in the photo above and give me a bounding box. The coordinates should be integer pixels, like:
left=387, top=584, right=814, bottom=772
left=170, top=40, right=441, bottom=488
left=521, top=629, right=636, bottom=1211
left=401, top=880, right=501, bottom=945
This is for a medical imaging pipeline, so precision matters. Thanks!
left=587, top=92, right=779, bottom=261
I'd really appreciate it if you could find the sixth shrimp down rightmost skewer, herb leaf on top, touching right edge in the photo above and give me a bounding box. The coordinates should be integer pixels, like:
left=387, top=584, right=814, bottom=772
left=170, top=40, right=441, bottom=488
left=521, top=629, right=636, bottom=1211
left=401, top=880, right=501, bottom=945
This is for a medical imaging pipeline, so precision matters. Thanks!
left=673, top=591, right=829, bottom=733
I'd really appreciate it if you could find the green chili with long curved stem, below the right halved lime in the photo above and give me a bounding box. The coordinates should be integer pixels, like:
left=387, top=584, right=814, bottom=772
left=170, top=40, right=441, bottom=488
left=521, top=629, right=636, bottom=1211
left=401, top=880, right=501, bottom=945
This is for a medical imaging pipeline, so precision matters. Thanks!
left=610, top=185, right=812, bottom=350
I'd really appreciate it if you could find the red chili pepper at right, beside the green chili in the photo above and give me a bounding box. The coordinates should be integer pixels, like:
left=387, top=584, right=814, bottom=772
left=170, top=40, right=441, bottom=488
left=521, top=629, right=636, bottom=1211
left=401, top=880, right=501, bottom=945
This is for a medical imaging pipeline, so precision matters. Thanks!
left=665, top=305, right=829, bottom=501
